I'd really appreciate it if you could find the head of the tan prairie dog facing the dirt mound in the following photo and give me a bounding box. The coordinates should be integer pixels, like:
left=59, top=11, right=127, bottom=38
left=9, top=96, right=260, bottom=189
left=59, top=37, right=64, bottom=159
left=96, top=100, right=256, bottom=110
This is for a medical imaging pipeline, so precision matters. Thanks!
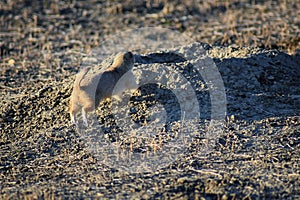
left=108, top=52, right=134, bottom=71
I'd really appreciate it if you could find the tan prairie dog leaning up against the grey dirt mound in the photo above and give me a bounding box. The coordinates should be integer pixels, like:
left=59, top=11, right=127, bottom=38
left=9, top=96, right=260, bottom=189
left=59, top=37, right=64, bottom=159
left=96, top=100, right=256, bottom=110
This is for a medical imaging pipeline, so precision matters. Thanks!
left=70, top=52, right=137, bottom=126
